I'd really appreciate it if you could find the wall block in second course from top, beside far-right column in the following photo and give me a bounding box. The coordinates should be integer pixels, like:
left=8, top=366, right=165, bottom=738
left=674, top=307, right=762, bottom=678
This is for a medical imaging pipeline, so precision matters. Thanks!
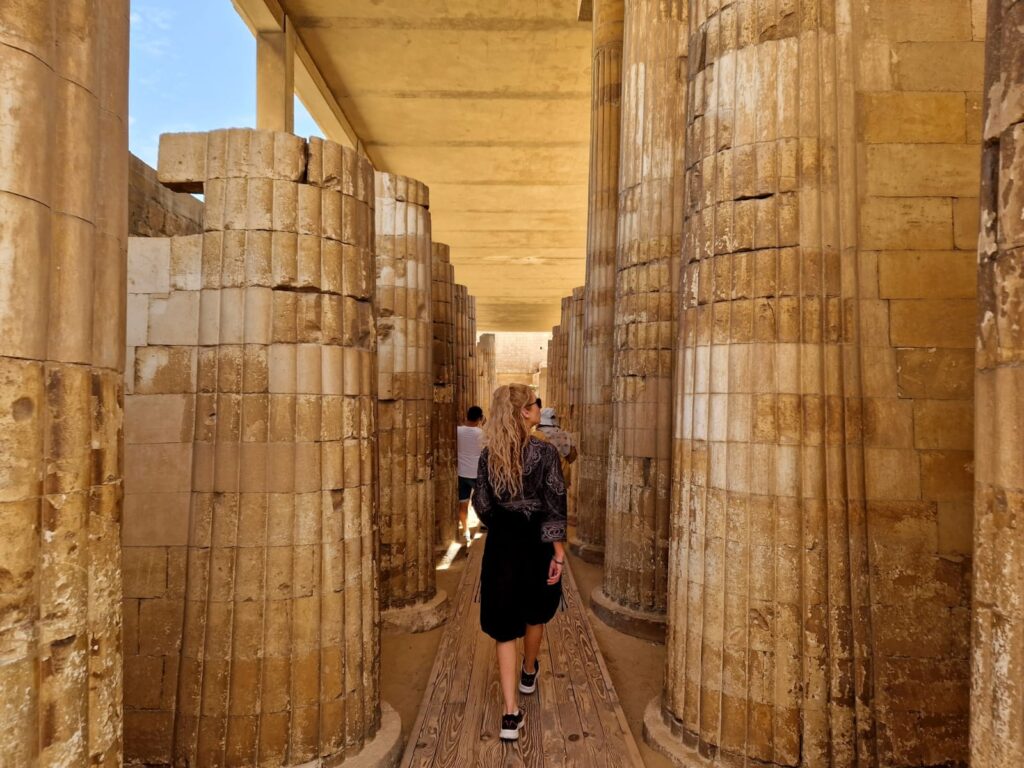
left=894, top=42, right=985, bottom=93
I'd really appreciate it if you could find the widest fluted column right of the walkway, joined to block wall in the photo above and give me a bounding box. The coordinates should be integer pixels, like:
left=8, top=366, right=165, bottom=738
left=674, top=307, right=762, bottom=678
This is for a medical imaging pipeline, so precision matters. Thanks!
left=645, top=1, right=876, bottom=768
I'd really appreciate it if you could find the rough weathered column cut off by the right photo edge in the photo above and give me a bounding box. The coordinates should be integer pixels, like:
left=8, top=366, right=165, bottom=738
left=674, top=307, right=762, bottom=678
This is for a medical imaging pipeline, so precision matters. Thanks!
left=971, top=0, right=1024, bottom=768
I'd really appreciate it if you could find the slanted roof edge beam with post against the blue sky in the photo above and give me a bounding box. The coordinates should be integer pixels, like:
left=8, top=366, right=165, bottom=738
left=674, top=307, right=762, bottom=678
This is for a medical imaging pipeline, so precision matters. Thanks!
left=231, top=0, right=373, bottom=154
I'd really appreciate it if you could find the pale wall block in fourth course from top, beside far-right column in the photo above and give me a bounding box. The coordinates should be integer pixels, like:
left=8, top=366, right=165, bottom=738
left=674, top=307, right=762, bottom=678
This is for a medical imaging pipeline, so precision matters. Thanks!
left=865, top=144, right=981, bottom=198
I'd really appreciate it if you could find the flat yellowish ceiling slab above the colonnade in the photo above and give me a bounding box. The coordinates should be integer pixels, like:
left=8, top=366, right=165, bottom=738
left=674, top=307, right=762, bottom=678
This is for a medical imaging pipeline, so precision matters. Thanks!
left=270, top=0, right=591, bottom=331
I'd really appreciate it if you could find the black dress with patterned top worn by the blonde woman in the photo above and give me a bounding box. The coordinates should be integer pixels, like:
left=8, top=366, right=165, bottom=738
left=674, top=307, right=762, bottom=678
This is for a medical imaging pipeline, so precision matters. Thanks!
left=473, top=437, right=565, bottom=642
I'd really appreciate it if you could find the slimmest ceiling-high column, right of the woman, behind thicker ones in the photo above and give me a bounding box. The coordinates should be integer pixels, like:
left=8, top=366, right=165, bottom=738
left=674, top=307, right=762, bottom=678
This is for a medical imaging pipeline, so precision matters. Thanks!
left=569, top=0, right=624, bottom=562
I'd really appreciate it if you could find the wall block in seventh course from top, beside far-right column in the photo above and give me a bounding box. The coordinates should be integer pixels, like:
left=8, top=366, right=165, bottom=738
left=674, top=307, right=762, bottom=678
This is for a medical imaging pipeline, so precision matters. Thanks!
left=890, top=299, right=976, bottom=349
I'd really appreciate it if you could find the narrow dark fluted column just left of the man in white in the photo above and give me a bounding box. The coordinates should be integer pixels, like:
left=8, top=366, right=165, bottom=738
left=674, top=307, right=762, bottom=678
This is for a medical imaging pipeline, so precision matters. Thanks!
left=430, top=243, right=459, bottom=550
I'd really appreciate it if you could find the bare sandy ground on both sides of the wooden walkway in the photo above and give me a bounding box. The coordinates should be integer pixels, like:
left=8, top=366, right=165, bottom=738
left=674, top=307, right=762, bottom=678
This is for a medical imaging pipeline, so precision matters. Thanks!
left=381, top=541, right=672, bottom=768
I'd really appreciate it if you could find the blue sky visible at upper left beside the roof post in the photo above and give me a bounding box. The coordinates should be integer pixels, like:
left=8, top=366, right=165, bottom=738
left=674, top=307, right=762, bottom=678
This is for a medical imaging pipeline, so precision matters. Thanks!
left=128, top=0, right=322, bottom=166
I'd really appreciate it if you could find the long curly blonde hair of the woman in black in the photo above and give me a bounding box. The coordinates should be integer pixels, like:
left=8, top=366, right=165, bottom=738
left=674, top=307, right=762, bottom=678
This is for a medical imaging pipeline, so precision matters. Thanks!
left=483, top=384, right=537, bottom=499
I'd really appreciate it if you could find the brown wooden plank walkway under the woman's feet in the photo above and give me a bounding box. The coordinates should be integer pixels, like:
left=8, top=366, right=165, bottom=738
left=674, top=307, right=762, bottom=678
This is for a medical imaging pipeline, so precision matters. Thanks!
left=401, top=540, right=643, bottom=768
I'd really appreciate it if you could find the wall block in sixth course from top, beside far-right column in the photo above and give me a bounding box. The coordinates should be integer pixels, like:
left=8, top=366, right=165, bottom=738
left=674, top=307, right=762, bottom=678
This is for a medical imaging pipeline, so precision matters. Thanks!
left=878, top=252, right=978, bottom=299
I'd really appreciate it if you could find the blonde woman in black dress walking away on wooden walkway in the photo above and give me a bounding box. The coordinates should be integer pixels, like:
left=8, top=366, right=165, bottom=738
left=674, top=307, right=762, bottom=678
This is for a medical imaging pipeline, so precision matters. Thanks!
left=473, top=384, right=565, bottom=740
